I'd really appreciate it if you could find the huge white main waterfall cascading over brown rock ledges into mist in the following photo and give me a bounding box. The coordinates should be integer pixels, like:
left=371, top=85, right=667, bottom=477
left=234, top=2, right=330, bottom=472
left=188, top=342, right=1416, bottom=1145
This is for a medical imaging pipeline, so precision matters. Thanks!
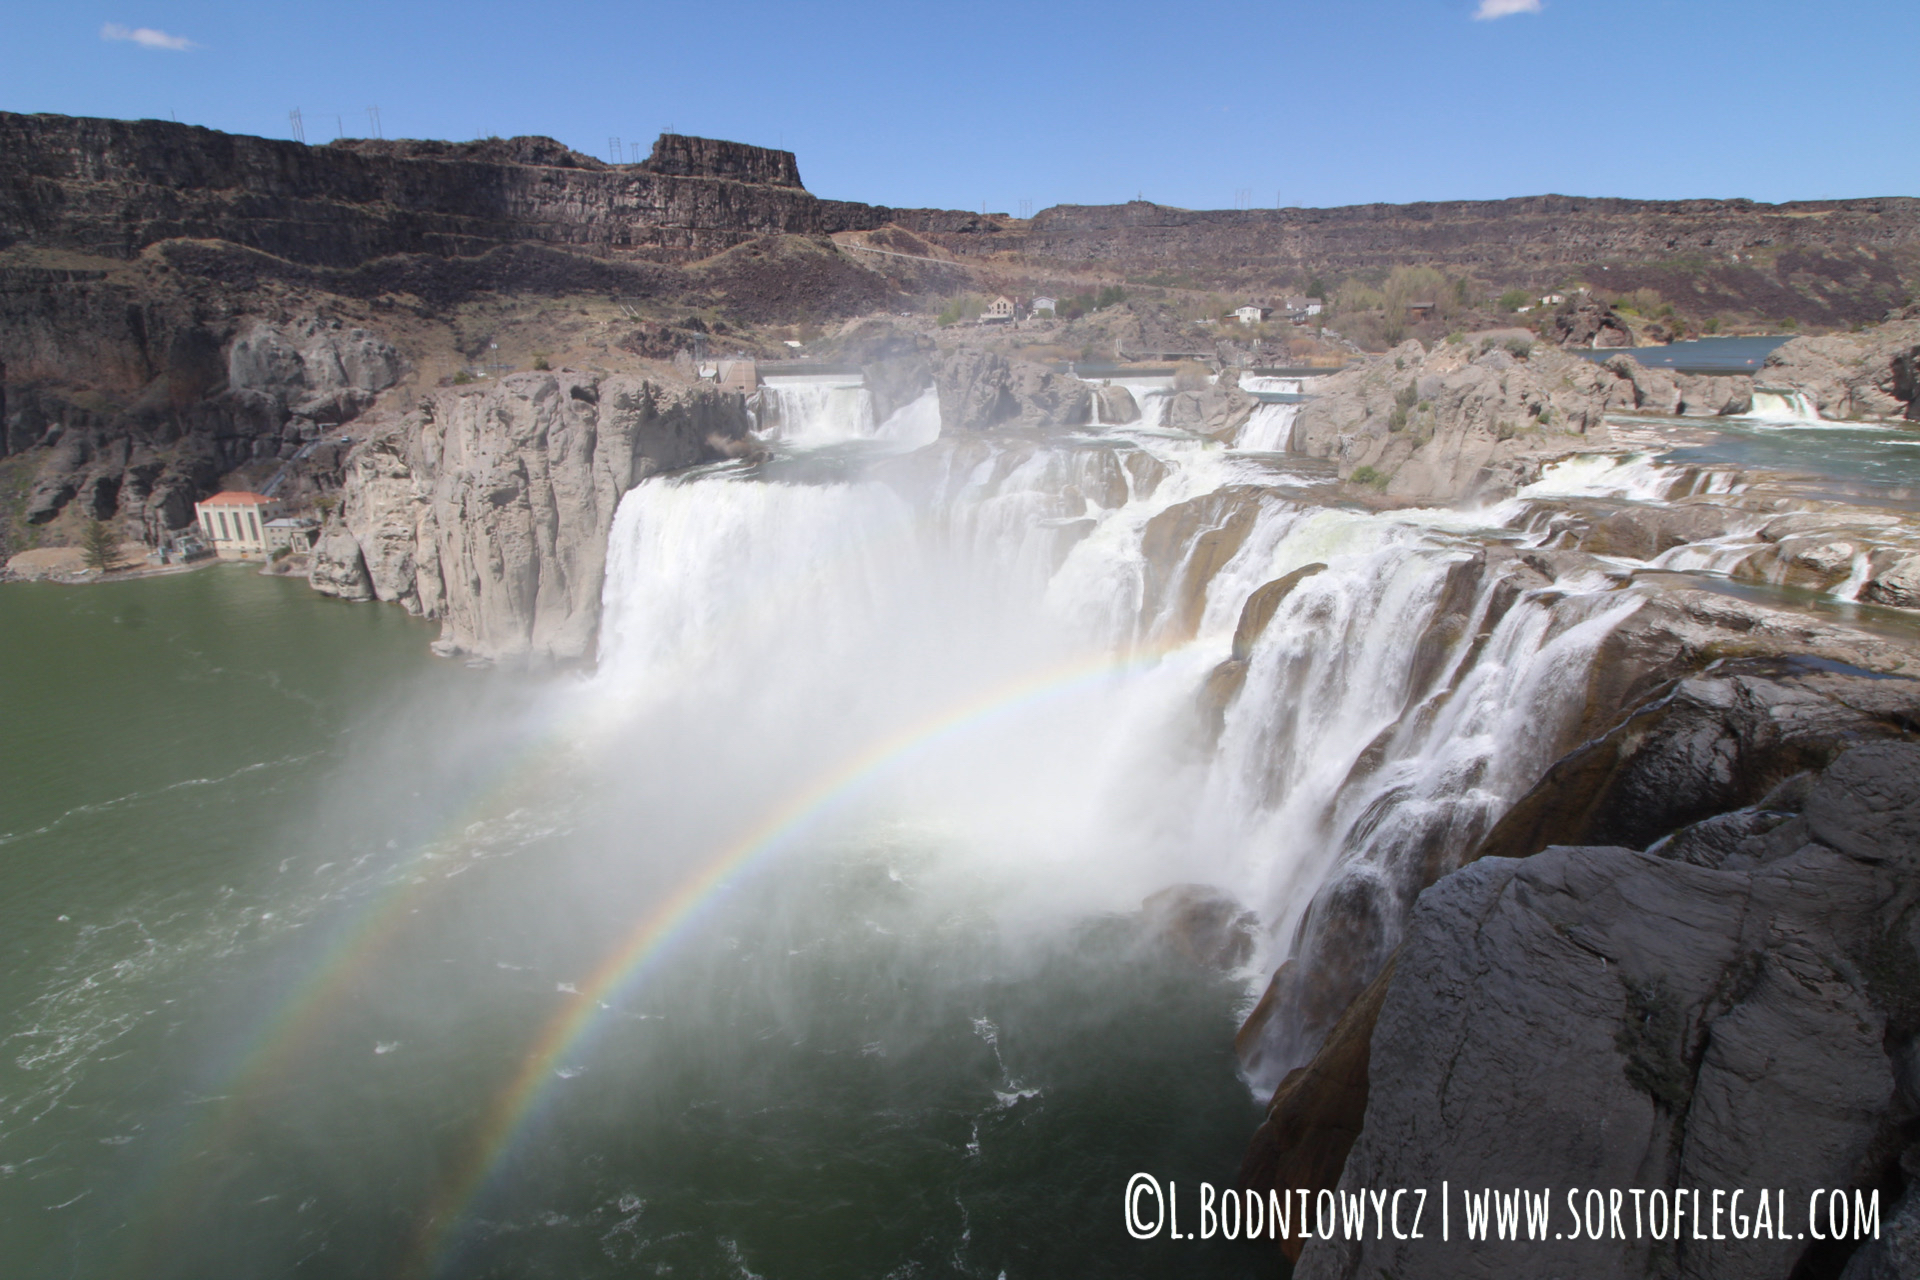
left=597, top=410, right=1674, bottom=1088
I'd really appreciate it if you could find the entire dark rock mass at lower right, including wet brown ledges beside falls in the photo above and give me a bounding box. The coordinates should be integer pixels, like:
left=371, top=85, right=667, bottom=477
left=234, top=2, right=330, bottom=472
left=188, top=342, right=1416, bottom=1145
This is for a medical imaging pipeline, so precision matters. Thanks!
left=1242, top=656, right=1920, bottom=1280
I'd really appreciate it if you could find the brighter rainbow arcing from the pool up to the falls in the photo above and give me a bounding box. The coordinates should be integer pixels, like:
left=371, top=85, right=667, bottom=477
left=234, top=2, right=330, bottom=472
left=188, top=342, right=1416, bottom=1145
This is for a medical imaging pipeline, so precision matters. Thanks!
left=401, top=649, right=1162, bottom=1278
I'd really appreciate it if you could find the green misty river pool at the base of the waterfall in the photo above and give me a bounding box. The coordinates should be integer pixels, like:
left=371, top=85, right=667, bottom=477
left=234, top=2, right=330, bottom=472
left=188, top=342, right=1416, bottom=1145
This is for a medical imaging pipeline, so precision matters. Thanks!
left=0, top=566, right=1283, bottom=1280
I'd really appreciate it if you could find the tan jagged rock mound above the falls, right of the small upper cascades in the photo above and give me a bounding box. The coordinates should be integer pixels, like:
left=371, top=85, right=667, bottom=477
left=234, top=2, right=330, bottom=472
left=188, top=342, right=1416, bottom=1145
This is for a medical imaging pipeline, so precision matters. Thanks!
left=1294, top=334, right=1638, bottom=501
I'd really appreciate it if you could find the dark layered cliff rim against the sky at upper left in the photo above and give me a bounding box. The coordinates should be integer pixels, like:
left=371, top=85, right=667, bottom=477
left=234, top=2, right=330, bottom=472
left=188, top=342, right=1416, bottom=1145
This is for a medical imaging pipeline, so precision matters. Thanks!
left=0, top=113, right=893, bottom=267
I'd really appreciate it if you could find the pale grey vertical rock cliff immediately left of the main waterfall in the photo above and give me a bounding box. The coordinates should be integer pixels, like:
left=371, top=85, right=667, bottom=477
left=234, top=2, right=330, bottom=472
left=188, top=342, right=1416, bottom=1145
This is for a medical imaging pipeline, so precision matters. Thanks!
left=313, top=370, right=747, bottom=662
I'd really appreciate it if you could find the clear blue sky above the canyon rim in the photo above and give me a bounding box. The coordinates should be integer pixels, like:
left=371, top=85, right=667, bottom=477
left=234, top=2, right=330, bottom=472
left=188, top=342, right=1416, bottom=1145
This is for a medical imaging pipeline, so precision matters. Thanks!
left=0, top=0, right=1920, bottom=213
